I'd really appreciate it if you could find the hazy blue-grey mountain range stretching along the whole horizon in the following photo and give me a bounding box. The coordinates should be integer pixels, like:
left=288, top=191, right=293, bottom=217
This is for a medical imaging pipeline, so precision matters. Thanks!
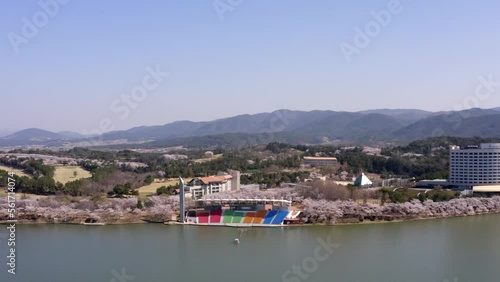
left=0, top=107, right=500, bottom=147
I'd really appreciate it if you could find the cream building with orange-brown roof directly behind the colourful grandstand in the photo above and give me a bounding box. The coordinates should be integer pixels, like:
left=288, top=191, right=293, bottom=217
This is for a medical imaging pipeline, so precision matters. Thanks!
left=184, top=170, right=240, bottom=200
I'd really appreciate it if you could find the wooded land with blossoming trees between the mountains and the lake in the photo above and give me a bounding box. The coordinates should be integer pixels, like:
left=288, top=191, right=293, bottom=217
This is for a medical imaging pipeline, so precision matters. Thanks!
left=0, top=137, right=499, bottom=224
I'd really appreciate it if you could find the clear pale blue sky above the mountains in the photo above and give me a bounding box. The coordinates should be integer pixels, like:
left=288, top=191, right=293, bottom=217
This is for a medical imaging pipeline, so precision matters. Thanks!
left=0, top=0, right=500, bottom=132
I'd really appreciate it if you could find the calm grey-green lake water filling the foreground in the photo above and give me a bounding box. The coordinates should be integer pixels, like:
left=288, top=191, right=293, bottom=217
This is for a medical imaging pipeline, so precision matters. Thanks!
left=0, top=215, right=500, bottom=282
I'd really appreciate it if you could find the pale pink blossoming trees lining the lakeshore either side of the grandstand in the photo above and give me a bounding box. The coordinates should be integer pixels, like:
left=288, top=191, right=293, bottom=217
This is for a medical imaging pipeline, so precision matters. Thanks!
left=0, top=196, right=500, bottom=225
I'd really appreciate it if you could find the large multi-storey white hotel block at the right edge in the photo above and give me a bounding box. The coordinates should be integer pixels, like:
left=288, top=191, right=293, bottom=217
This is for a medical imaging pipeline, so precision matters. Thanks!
left=448, top=143, right=500, bottom=190
